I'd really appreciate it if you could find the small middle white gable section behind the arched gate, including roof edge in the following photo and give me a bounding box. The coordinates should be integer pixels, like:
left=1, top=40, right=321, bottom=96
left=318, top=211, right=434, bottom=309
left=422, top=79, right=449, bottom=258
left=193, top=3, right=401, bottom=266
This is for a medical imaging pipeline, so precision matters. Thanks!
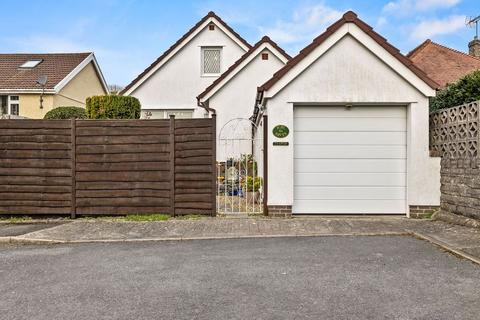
left=197, top=37, right=291, bottom=160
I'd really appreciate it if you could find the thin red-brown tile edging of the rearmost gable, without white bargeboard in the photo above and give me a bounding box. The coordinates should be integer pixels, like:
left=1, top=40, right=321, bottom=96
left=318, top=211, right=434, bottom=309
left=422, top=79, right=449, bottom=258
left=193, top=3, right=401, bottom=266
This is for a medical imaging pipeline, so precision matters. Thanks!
left=120, top=11, right=252, bottom=95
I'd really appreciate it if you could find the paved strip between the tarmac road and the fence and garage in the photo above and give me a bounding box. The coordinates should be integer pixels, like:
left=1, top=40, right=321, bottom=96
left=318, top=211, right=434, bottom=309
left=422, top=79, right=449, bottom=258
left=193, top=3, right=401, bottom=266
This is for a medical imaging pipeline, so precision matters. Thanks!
left=0, top=217, right=480, bottom=263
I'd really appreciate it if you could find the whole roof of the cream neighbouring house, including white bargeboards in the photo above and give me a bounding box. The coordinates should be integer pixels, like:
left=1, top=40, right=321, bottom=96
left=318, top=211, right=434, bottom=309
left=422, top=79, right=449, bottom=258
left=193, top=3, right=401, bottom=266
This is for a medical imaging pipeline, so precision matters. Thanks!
left=0, top=52, right=108, bottom=92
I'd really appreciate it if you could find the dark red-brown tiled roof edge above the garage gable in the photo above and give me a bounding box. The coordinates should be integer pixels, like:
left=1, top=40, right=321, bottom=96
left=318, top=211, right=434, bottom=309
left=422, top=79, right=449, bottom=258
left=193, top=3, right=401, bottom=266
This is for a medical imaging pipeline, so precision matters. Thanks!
left=258, top=11, right=438, bottom=92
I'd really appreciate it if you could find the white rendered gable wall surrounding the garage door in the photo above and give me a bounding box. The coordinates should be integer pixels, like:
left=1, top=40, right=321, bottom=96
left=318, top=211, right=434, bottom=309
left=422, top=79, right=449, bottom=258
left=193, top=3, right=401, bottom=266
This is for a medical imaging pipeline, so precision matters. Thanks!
left=266, top=36, right=440, bottom=210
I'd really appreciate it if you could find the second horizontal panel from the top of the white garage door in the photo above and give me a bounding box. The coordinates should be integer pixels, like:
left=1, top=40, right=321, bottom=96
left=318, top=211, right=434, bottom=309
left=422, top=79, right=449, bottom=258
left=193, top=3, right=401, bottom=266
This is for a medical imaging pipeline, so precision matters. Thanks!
left=294, top=117, right=407, bottom=132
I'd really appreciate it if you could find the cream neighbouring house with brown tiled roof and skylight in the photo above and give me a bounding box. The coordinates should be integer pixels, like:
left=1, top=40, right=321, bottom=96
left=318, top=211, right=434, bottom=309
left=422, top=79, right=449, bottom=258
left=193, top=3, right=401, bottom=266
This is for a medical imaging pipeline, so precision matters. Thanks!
left=0, top=52, right=108, bottom=119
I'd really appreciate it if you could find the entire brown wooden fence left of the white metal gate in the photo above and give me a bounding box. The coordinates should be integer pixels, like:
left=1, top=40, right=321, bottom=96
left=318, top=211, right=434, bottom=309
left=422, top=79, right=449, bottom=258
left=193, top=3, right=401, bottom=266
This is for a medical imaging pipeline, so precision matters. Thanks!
left=0, top=117, right=216, bottom=217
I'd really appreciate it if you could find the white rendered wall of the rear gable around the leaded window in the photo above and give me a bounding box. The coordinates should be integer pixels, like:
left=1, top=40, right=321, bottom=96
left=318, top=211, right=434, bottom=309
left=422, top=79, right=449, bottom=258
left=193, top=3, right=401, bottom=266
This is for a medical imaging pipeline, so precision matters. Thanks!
left=130, top=26, right=245, bottom=118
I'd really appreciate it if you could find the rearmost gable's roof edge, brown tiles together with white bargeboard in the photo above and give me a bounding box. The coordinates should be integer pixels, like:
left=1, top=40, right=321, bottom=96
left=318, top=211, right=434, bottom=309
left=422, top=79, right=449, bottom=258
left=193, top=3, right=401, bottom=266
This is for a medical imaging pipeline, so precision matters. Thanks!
left=120, top=11, right=252, bottom=95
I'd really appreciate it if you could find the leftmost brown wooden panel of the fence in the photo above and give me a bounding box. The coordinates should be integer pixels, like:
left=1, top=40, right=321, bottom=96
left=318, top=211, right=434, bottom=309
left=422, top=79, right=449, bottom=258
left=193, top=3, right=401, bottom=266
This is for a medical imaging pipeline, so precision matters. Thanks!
left=0, top=120, right=72, bottom=214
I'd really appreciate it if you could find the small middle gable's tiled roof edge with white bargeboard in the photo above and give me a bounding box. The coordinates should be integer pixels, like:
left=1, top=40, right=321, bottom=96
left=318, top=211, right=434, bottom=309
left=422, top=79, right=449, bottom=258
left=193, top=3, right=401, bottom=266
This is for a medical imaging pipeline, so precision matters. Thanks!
left=197, top=36, right=292, bottom=101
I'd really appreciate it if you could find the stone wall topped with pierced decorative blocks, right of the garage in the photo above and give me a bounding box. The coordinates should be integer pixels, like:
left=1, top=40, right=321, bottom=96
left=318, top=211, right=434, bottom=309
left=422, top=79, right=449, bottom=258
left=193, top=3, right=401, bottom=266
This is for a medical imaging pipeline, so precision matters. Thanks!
left=430, top=101, right=480, bottom=220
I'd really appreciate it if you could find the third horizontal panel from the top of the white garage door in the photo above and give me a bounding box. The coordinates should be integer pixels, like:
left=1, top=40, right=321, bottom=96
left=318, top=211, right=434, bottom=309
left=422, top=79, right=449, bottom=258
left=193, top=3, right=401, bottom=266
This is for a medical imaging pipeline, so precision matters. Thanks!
left=294, top=131, right=407, bottom=145
